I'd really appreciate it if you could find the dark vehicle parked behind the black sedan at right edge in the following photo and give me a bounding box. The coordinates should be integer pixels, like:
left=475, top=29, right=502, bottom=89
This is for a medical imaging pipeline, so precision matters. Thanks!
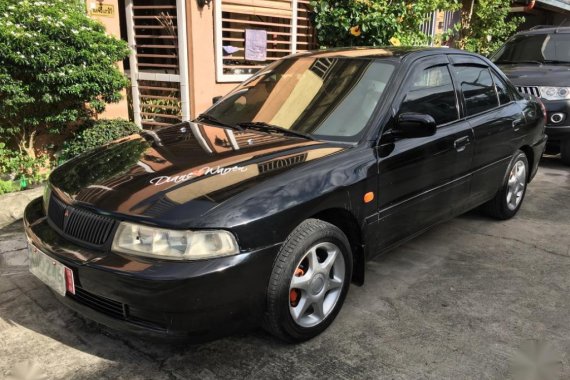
left=491, top=26, right=570, bottom=165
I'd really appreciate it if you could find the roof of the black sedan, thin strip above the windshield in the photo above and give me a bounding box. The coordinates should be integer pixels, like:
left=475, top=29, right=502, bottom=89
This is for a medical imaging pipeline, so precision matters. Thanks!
left=294, top=46, right=476, bottom=59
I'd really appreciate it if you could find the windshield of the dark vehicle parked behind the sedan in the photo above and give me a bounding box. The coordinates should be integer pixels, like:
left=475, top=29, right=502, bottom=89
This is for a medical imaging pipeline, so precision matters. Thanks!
left=492, top=33, right=570, bottom=63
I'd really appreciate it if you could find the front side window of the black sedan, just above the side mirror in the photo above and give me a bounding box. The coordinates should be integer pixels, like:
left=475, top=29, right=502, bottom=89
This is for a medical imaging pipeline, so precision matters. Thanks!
left=400, top=66, right=459, bottom=125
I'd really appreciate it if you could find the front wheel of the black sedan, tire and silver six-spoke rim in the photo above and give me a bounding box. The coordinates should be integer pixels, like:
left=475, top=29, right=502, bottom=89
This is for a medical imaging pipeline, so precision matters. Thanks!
left=264, top=219, right=352, bottom=342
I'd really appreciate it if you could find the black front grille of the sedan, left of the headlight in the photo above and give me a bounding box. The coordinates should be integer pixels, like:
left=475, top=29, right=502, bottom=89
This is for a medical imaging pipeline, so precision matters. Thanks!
left=48, top=195, right=115, bottom=246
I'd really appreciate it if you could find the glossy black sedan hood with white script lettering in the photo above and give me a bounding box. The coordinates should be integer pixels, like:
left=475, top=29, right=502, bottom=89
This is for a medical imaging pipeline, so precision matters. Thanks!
left=49, top=122, right=348, bottom=226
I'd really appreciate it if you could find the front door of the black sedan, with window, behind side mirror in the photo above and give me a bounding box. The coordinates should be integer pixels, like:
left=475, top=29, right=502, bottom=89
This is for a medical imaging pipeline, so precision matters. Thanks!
left=378, top=55, right=473, bottom=248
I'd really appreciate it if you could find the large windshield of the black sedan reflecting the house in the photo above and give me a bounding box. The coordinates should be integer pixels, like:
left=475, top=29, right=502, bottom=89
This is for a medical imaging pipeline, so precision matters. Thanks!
left=207, top=57, right=394, bottom=141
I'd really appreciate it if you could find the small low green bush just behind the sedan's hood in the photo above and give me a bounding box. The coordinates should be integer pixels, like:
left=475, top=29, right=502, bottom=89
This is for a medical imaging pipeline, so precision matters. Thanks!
left=60, top=119, right=140, bottom=161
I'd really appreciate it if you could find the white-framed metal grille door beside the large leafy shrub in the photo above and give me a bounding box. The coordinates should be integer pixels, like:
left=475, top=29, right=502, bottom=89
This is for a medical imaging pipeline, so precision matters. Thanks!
left=125, top=0, right=190, bottom=128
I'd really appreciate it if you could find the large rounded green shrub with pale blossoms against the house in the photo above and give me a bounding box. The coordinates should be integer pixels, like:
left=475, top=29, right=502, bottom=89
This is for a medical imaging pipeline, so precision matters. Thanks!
left=0, top=0, right=129, bottom=157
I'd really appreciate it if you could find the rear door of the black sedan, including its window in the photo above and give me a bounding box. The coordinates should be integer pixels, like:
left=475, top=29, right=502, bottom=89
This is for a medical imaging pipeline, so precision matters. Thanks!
left=451, top=55, right=525, bottom=206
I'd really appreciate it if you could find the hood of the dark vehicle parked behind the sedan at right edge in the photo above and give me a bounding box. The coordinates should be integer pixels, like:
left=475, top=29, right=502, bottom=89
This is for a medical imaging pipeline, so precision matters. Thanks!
left=499, top=64, right=570, bottom=86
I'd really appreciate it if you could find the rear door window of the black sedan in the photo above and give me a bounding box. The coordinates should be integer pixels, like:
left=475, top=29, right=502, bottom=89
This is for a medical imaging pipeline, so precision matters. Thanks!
left=454, top=66, right=499, bottom=116
